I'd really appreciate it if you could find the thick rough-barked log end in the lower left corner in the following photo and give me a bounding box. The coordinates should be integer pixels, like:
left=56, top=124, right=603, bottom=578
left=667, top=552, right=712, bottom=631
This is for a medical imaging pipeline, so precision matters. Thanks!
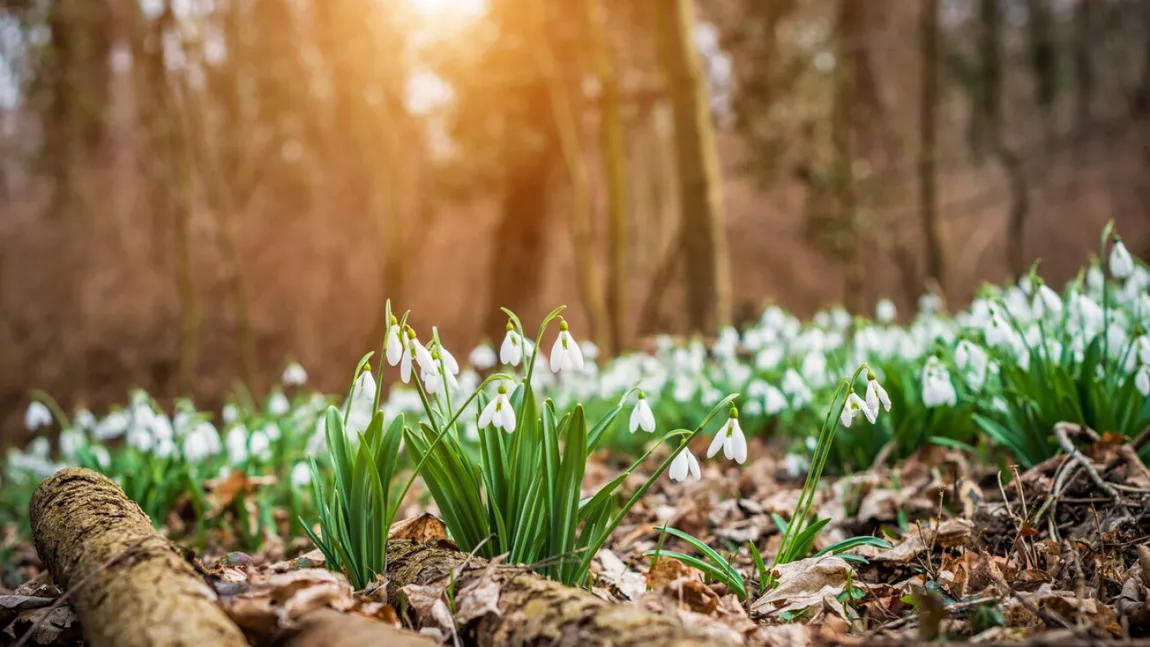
left=29, top=469, right=247, bottom=647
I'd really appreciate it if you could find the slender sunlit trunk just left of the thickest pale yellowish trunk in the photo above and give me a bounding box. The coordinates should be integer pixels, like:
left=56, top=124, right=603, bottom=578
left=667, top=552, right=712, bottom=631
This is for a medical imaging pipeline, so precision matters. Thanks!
left=587, top=0, right=630, bottom=353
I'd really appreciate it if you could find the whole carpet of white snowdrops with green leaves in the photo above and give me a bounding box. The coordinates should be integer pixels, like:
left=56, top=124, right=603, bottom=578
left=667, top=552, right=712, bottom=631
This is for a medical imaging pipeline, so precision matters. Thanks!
left=0, top=228, right=1150, bottom=581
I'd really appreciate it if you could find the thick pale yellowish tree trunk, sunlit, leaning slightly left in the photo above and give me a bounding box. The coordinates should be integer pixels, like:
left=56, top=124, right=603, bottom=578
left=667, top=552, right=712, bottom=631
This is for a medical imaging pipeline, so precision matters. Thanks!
left=656, top=0, right=731, bottom=334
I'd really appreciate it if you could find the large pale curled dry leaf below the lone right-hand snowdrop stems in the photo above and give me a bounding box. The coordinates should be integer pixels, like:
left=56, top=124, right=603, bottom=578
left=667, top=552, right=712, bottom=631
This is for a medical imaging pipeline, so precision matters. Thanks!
left=751, top=555, right=861, bottom=618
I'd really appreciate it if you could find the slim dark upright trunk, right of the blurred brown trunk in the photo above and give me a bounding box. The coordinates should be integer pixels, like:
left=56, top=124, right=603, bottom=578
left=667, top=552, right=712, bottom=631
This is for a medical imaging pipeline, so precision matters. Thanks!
left=919, top=0, right=946, bottom=293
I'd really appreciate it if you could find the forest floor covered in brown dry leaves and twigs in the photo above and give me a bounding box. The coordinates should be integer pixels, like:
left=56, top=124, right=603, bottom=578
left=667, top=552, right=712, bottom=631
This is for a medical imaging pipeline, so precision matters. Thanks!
left=0, top=429, right=1150, bottom=646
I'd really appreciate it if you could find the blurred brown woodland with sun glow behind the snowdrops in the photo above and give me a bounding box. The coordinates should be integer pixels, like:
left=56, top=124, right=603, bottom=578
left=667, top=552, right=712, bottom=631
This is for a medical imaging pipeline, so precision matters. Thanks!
left=0, top=0, right=1150, bottom=440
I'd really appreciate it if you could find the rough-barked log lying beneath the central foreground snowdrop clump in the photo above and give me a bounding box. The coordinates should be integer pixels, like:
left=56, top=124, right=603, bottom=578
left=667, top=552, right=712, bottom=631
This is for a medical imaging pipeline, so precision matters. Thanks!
left=388, top=540, right=738, bottom=647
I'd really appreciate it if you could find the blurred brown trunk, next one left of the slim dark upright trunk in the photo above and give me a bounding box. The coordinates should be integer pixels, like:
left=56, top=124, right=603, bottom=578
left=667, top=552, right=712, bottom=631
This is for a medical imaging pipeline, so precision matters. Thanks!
left=830, top=0, right=864, bottom=314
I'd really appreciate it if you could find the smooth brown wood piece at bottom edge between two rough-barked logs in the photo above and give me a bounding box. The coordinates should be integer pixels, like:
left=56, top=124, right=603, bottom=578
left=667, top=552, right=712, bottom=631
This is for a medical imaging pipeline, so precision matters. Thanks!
left=271, top=609, right=438, bottom=647
